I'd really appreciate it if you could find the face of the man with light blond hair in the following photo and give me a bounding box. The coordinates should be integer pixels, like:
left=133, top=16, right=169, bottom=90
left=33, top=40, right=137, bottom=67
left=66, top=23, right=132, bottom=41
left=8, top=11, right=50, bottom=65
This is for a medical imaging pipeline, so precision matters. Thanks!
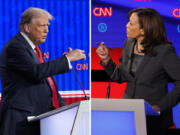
left=25, top=16, right=50, bottom=45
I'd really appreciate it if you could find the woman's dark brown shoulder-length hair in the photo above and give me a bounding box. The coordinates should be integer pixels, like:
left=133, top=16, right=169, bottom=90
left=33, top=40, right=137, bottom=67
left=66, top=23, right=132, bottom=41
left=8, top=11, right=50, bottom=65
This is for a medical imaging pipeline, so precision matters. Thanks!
left=127, top=8, right=172, bottom=55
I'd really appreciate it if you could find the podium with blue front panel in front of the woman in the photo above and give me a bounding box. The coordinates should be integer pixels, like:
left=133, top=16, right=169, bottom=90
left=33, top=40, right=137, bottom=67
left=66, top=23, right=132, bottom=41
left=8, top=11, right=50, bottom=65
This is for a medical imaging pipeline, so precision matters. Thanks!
left=91, top=99, right=159, bottom=135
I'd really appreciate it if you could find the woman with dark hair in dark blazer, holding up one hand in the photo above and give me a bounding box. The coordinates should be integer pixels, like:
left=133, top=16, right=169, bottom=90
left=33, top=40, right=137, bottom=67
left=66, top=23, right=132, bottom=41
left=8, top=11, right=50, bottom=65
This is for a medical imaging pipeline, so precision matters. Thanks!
left=96, top=8, right=180, bottom=135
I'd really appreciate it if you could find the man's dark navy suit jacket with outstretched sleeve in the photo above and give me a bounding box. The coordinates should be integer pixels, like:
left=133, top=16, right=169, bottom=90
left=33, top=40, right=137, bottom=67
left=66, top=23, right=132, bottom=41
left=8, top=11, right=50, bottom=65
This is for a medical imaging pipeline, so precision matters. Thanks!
left=0, top=33, right=69, bottom=135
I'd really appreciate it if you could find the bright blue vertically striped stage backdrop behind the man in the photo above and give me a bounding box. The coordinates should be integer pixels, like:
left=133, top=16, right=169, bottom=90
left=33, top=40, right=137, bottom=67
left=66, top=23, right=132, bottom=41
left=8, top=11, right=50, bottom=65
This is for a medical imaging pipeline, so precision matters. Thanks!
left=0, top=0, right=90, bottom=102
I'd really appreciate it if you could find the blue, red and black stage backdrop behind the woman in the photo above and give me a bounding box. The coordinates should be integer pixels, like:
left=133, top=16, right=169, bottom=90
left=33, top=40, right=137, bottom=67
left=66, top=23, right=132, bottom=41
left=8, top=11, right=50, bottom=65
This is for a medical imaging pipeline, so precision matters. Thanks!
left=91, top=0, right=180, bottom=128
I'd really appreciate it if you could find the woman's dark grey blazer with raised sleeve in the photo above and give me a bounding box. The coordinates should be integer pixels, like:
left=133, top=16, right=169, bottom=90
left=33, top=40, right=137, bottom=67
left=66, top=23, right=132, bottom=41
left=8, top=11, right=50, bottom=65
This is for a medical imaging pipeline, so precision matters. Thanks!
left=101, top=39, right=180, bottom=127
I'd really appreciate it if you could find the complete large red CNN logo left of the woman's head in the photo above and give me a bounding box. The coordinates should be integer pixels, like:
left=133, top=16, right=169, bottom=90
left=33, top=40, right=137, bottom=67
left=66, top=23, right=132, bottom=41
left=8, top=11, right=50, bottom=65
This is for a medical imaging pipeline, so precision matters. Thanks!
left=93, top=7, right=112, bottom=17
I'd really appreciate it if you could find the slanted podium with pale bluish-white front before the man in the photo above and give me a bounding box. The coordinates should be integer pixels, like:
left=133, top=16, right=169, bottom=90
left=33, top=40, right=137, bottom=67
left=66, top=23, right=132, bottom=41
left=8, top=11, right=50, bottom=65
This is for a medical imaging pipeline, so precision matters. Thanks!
left=27, top=100, right=90, bottom=135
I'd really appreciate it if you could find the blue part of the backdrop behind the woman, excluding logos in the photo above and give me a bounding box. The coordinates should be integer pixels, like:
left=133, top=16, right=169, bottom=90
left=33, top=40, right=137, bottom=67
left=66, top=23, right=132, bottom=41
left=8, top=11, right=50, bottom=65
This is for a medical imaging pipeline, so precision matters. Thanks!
left=91, top=0, right=180, bottom=128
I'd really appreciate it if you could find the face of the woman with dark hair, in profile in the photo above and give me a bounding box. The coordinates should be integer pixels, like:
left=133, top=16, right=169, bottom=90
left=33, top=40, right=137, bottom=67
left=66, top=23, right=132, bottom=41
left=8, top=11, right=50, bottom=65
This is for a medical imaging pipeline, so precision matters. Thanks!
left=126, top=13, right=144, bottom=39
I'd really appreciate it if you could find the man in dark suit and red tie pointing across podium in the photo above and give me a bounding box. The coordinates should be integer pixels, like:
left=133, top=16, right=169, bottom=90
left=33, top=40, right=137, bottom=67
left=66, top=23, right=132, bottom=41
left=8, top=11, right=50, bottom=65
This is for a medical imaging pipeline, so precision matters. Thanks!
left=0, top=8, right=85, bottom=135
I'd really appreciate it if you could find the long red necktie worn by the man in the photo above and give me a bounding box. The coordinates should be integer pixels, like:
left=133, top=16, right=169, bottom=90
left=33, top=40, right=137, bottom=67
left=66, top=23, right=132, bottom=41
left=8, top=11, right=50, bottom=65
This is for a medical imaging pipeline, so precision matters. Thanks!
left=34, top=46, right=59, bottom=108
